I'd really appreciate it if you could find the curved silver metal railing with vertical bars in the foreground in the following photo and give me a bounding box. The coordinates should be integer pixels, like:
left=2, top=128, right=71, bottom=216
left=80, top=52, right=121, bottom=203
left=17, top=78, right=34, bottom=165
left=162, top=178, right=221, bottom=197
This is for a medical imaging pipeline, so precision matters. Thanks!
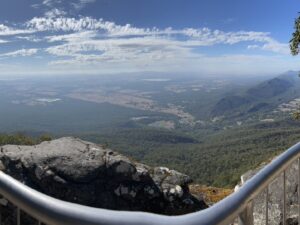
left=0, top=143, right=300, bottom=225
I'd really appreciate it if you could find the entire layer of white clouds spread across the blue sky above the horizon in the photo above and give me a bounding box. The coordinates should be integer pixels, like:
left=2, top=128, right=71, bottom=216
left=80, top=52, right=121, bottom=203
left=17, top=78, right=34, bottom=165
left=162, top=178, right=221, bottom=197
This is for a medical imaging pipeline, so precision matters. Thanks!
left=0, top=13, right=297, bottom=73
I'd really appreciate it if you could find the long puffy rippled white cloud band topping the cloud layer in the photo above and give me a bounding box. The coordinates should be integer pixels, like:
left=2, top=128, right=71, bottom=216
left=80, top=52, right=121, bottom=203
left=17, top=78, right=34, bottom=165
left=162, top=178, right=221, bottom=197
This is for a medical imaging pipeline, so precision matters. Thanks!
left=26, top=17, right=287, bottom=53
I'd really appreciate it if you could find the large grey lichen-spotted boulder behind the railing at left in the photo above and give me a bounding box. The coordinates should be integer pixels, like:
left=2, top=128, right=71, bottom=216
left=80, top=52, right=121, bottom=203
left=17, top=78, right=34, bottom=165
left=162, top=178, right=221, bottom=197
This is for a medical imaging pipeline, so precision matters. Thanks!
left=0, top=137, right=207, bottom=215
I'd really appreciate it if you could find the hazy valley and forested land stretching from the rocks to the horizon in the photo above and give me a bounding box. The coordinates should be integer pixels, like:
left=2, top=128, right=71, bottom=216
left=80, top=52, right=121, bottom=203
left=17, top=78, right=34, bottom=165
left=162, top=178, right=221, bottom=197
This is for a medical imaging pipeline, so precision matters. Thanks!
left=0, top=71, right=300, bottom=187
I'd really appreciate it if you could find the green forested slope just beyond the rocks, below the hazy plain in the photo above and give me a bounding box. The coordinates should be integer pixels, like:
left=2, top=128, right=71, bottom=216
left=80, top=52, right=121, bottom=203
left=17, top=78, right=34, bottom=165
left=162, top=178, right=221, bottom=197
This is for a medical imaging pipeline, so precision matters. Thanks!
left=78, top=119, right=300, bottom=187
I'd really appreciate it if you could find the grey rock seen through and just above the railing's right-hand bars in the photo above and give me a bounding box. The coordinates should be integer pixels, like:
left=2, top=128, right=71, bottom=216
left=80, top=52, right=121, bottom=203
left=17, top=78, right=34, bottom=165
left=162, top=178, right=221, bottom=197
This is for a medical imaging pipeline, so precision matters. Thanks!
left=241, top=162, right=298, bottom=225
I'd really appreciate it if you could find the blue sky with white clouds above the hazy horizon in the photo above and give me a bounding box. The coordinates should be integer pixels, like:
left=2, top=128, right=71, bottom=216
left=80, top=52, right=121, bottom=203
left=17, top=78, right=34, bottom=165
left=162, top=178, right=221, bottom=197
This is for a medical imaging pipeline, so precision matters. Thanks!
left=0, top=0, right=300, bottom=76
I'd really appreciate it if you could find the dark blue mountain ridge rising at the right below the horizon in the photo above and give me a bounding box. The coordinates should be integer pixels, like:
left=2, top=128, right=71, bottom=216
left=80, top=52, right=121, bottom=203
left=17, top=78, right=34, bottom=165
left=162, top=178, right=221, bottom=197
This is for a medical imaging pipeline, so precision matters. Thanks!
left=211, top=71, right=300, bottom=117
